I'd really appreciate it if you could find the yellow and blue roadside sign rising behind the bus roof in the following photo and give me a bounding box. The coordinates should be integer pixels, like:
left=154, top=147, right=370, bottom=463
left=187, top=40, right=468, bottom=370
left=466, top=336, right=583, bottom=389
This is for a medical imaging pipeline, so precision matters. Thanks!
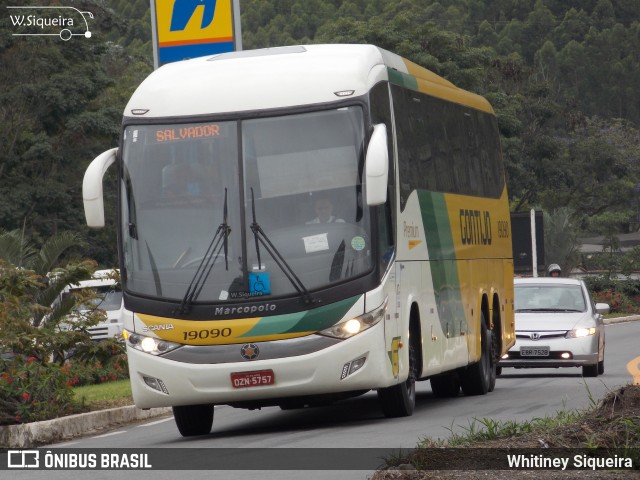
left=153, top=0, right=235, bottom=65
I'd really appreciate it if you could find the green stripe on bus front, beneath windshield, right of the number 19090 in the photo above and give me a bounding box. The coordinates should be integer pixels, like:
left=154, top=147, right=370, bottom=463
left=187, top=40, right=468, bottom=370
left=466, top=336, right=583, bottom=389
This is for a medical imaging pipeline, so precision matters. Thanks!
left=242, top=295, right=360, bottom=337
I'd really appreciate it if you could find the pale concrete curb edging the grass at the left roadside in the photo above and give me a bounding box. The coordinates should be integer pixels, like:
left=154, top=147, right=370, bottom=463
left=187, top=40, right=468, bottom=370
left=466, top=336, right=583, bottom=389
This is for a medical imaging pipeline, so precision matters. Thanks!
left=0, top=405, right=171, bottom=448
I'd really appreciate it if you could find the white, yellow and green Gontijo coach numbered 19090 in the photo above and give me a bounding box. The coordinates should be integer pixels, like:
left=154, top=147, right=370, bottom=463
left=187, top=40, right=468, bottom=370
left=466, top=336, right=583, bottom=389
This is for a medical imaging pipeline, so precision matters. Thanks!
left=83, top=44, right=515, bottom=436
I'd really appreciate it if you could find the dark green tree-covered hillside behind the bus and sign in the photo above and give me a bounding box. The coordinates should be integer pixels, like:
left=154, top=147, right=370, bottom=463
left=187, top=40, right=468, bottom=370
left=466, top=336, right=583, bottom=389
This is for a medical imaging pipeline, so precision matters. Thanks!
left=0, top=0, right=640, bottom=265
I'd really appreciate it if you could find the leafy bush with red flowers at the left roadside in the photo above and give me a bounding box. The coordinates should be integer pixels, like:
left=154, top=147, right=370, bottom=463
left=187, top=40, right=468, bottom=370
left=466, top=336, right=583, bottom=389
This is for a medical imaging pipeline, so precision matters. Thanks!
left=0, top=260, right=128, bottom=425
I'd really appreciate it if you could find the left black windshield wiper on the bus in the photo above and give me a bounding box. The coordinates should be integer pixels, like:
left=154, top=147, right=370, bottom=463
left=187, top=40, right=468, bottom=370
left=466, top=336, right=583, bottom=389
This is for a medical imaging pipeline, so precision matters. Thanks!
left=179, top=187, right=231, bottom=314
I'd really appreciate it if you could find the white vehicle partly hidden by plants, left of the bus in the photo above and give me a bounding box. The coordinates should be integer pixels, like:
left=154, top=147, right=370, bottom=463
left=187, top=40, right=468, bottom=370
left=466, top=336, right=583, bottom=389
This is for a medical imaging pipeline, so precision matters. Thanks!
left=60, top=270, right=123, bottom=340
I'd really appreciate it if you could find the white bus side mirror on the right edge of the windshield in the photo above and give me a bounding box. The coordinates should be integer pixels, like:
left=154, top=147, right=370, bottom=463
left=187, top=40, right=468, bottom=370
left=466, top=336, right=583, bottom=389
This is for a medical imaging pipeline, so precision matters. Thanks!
left=365, top=123, right=389, bottom=206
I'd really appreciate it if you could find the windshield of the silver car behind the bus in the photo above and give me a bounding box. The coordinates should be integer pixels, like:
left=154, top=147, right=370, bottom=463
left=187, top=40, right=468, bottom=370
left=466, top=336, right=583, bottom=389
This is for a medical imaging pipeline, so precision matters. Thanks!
left=515, top=284, right=587, bottom=312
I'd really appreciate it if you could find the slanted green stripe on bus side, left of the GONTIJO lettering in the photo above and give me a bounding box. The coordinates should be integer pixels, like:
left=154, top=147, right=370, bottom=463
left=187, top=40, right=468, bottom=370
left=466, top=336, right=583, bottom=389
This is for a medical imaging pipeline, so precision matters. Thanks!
left=417, top=191, right=466, bottom=337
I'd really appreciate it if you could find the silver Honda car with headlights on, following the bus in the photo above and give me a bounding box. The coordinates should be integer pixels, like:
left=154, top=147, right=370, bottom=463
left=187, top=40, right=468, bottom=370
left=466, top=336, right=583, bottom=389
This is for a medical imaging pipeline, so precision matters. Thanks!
left=498, top=278, right=609, bottom=377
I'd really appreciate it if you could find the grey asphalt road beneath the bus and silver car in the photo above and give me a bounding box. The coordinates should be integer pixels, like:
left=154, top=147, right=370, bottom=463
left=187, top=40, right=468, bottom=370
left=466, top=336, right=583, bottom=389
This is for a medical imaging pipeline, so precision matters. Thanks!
left=12, top=322, right=640, bottom=480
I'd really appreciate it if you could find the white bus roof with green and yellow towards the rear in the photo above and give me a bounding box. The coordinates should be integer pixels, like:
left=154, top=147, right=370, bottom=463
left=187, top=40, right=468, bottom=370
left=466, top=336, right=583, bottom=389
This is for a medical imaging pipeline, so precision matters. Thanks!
left=125, top=44, right=493, bottom=118
